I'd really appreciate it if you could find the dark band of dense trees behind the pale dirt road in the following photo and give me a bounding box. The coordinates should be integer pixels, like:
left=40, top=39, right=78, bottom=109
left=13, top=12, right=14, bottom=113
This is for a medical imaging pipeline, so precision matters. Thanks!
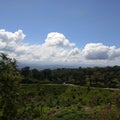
left=21, top=66, right=120, bottom=88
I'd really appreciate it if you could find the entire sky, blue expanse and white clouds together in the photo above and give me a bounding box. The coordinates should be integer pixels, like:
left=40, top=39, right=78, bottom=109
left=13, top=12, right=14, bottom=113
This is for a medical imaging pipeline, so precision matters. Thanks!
left=0, top=0, right=120, bottom=66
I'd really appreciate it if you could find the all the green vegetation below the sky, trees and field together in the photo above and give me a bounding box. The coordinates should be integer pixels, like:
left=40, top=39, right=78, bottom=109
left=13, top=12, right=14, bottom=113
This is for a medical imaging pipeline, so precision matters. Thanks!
left=0, top=54, right=120, bottom=120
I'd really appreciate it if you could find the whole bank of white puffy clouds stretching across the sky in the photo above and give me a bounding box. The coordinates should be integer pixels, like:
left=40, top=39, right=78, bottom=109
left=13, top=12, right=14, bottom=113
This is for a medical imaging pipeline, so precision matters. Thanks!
left=0, top=29, right=120, bottom=65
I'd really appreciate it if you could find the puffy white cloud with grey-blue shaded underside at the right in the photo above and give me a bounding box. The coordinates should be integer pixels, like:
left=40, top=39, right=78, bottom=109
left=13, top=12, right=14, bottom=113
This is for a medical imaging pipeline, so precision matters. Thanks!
left=83, top=43, right=120, bottom=60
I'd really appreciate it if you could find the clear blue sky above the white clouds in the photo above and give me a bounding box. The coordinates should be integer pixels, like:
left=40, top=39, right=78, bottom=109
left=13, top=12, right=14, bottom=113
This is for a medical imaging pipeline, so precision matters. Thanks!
left=0, top=0, right=120, bottom=64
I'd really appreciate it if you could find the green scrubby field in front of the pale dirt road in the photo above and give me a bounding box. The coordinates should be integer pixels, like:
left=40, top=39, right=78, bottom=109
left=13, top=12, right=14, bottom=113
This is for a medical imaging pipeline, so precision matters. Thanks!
left=16, top=84, right=120, bottom=120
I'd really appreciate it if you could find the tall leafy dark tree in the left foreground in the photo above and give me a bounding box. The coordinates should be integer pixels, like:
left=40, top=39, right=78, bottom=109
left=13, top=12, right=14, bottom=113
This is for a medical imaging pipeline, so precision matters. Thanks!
left=0, top=53, right=20, bottom=120
